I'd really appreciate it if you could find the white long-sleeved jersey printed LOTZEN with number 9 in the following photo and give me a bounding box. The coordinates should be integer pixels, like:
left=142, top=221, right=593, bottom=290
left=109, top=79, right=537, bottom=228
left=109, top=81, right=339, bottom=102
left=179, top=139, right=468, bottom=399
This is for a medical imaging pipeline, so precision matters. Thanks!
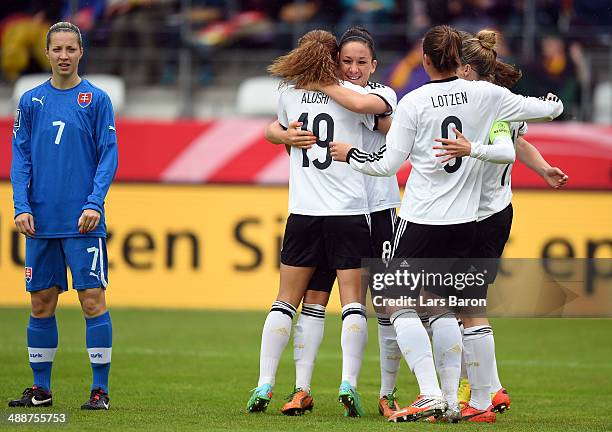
left=348, top=77, right=563, bottom=225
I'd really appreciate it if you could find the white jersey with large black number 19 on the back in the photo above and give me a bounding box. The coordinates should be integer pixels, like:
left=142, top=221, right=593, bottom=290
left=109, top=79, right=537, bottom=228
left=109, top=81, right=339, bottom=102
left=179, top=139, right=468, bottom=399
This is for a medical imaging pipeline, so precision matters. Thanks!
left=278, top=82, right=374, bottom=216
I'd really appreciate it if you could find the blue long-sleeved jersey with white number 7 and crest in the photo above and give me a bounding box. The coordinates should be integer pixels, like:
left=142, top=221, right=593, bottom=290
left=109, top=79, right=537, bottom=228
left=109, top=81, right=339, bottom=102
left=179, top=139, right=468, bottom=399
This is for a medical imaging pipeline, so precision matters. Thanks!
left=11, top=79, right=117, bottom=238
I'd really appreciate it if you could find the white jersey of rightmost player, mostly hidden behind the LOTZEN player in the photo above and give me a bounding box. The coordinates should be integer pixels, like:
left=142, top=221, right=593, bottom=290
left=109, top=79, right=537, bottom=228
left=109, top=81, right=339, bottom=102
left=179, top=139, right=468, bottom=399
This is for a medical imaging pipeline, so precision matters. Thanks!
left=478, top=122, right=527, bottom=221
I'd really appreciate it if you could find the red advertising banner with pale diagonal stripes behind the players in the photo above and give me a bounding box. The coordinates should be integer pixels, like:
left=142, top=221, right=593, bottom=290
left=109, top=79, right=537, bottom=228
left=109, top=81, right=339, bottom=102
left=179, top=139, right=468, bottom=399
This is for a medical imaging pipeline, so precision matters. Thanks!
left=0, top=118, right=612, bottom=190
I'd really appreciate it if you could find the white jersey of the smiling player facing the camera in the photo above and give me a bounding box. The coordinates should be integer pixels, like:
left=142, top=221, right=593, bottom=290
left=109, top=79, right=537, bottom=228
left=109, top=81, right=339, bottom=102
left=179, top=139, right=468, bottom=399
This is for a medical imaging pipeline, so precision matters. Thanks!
left=363, top=82, right=401, bottom=213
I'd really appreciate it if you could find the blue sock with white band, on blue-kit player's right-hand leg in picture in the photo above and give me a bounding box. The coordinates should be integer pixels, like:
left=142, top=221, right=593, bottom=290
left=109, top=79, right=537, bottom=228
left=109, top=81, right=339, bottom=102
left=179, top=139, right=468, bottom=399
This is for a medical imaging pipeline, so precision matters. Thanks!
left=85, top=311, right=113, bottom=393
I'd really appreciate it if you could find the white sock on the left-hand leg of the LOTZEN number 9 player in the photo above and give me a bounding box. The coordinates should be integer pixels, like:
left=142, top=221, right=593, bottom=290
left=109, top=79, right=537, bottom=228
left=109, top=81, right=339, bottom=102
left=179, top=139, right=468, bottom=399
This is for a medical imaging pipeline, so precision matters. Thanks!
left=391, top=309, right=442, bottom=397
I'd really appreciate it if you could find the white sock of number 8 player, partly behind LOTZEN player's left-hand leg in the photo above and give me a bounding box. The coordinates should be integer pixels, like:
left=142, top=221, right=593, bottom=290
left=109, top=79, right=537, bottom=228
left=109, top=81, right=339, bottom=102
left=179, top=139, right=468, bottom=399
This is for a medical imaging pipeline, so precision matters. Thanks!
left=378, top=314, right=402, bottom=397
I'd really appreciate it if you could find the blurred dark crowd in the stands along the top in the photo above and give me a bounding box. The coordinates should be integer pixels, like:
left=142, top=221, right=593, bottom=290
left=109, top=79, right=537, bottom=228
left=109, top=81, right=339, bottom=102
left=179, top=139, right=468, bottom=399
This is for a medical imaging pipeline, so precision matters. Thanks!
left=0, top=0, right=612, bottom=118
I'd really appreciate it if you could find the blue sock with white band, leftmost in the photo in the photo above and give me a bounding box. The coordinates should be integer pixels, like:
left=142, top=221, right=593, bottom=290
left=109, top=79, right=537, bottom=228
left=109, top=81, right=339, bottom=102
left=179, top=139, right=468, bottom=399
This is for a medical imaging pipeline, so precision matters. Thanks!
left=28, top=315, right=57, bottom=391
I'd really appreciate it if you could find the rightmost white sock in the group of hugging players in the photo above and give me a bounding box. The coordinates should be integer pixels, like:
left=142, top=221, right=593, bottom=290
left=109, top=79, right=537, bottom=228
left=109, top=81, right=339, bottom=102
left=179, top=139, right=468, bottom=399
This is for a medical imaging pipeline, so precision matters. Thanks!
left=463, top=326, right=495, bottom=410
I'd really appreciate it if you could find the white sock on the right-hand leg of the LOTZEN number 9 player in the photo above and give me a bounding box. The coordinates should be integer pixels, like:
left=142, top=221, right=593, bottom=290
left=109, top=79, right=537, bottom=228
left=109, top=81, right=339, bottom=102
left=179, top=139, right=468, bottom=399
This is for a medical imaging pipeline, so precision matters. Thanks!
left=429, top=313, right=463, bottom=407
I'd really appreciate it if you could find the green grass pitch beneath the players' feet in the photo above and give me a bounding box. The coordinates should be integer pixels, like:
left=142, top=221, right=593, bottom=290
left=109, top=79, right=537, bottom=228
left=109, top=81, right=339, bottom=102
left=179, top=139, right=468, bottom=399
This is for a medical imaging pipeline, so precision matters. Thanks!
left=0, top=308, right=612, bottom=432
